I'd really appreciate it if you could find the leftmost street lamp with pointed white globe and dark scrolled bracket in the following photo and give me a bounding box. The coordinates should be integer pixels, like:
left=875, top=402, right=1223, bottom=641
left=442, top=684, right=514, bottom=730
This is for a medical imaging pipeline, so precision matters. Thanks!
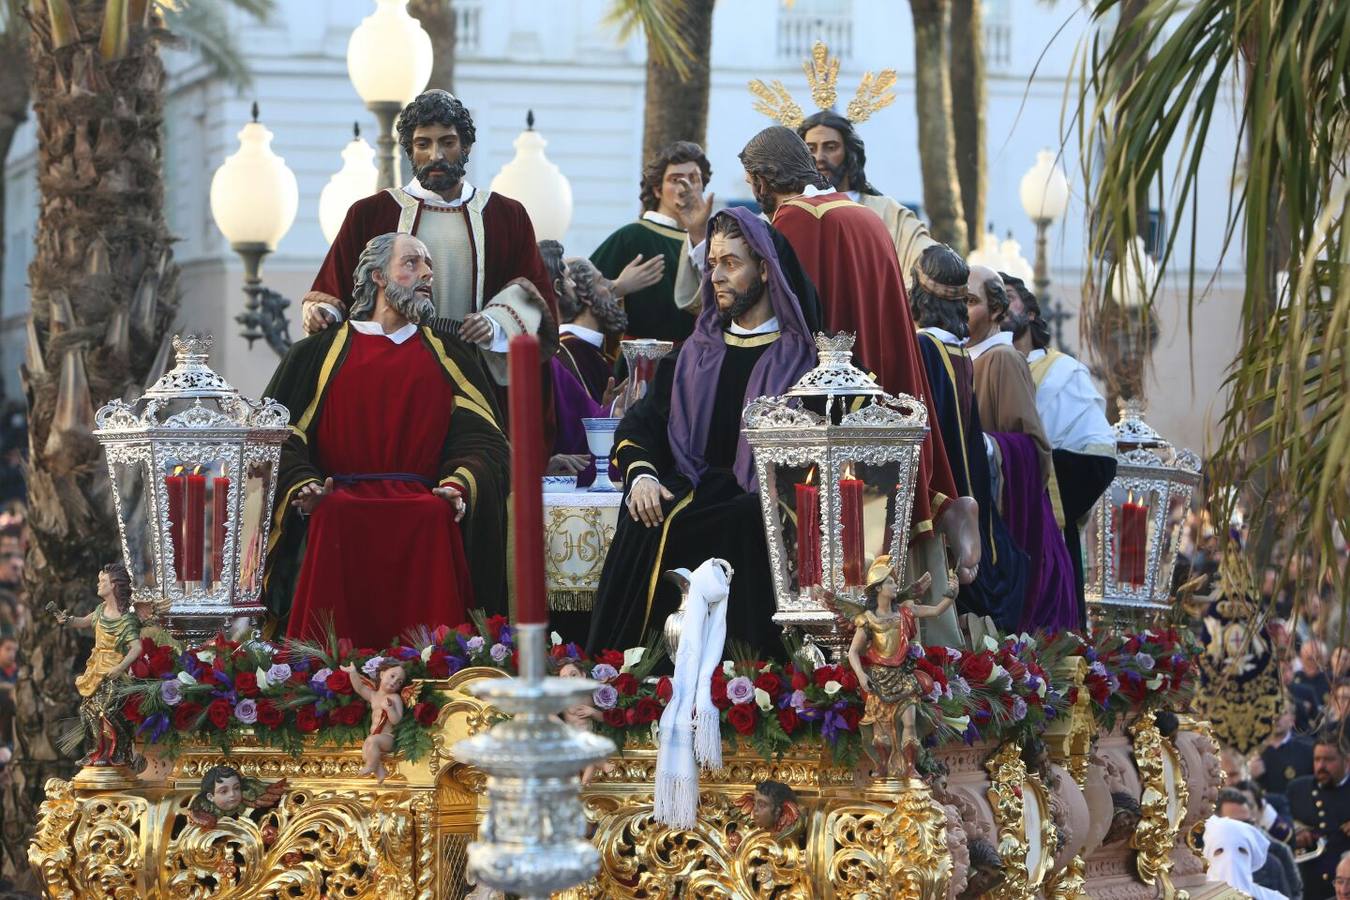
left=211, top=103, right=300, bottom=355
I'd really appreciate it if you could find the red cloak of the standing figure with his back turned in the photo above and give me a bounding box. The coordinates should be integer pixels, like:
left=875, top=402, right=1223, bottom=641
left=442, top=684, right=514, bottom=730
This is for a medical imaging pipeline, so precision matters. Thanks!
left=774, top=193, right=959, bottom=533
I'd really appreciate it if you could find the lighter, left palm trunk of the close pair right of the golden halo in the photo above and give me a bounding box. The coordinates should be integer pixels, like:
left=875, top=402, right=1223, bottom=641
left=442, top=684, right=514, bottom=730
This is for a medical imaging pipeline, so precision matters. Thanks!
left=910, top=0, right=967, bottom=255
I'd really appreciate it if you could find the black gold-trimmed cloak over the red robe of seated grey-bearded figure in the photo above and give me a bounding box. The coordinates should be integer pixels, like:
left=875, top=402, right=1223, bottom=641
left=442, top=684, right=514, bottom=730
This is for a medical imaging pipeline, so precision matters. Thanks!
left=263, top=322, right=510, bottom=622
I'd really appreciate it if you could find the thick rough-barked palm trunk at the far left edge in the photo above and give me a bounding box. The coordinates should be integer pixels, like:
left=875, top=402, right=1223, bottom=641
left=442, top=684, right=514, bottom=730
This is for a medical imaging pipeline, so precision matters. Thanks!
left=4, top=0, right=178, bottom=877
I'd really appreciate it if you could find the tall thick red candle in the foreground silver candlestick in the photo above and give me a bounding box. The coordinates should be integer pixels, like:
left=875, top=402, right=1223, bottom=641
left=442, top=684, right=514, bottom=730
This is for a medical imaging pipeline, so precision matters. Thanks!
left=509, top=335, right=548, bottom=625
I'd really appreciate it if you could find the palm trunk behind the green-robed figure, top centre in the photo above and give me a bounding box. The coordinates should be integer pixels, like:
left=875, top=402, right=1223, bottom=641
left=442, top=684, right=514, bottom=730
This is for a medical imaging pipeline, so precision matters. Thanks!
left=643, top=0, right=713, bottom=161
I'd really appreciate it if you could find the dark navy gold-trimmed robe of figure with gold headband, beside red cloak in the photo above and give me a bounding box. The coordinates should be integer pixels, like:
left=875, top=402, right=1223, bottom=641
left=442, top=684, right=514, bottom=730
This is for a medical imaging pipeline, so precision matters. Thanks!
left=919, top=332, right=1030, bottom=631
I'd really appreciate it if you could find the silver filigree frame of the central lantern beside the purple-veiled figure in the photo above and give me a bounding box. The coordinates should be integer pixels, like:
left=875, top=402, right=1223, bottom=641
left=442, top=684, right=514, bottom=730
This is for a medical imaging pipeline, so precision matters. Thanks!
left=741, top=333, right=927, bottom=654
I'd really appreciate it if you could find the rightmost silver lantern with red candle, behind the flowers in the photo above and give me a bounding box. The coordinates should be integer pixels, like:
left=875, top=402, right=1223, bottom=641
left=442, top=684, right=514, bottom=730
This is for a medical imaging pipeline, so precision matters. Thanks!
left=1084, top=399, right=1200, bottom=625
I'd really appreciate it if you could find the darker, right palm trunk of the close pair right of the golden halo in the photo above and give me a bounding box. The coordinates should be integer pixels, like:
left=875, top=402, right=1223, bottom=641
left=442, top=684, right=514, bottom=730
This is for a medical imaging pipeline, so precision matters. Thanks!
left=950, top=0, right=988, bottom=244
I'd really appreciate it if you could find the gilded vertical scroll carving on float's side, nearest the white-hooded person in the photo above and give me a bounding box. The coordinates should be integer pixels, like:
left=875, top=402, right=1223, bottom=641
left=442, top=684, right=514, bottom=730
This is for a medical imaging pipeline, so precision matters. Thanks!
left=1129, top=710, right=1188, bottom=900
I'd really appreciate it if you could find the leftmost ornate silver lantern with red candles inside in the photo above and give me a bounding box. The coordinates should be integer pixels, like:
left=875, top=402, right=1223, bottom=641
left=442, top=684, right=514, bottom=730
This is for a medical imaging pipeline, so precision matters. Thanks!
left=95, top=336, right=290, bottom=638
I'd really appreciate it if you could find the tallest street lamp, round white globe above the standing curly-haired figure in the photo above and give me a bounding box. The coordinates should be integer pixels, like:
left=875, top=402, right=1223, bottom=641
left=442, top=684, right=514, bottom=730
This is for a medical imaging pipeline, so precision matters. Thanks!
left=347, top=0, right=432, bottom=189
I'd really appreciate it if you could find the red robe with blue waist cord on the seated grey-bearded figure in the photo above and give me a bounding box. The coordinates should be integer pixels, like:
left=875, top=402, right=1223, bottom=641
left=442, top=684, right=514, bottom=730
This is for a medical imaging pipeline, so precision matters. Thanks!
left=288, top=332, right=474, bottom=648
